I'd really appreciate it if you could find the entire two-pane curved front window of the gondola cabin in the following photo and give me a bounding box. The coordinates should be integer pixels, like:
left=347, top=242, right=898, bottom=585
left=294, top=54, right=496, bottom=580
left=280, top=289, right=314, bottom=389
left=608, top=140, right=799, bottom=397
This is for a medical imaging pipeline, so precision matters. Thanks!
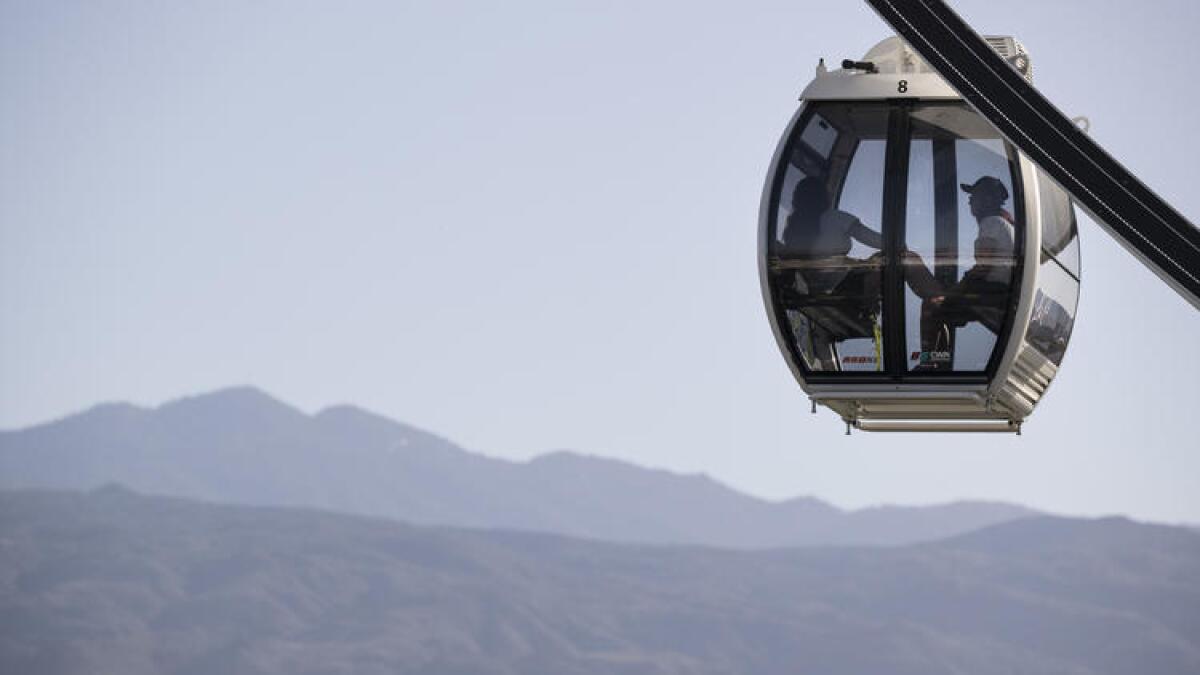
left=767, top=102, right=1024, bottom=381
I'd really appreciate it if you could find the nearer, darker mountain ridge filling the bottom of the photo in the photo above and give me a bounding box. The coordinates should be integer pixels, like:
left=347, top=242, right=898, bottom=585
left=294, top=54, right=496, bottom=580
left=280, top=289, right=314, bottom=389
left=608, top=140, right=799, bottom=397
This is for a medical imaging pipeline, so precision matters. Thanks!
left=0, top=487, right=1200, bottom=675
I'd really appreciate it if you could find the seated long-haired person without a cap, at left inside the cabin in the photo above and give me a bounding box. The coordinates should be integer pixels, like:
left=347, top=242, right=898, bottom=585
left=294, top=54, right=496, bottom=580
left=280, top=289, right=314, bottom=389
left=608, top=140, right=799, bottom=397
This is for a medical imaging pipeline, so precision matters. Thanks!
left=779, top=177, right=883, bottom=362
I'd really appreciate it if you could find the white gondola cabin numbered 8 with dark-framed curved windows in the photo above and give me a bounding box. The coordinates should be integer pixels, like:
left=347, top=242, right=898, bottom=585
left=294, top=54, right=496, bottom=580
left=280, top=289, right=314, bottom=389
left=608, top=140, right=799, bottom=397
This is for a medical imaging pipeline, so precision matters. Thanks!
left=758, top=37, right=1080, bottom=432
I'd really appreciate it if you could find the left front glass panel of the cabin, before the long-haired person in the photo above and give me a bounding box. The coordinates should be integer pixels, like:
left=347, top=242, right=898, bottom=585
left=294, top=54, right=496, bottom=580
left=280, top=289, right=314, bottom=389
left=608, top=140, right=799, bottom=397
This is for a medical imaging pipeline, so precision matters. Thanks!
left=768, top=103, right=888, bottom=372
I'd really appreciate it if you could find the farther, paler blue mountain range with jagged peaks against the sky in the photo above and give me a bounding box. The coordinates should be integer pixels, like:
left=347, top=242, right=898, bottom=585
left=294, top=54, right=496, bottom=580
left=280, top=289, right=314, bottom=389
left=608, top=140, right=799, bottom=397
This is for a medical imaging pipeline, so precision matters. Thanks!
left=0, top=388, right=1032, bottom=548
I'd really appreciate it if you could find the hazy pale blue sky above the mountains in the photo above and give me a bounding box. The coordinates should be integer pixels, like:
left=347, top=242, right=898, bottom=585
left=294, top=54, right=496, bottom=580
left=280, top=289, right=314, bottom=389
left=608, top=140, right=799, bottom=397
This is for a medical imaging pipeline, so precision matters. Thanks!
left=0, top=0, right=1200, bottom=521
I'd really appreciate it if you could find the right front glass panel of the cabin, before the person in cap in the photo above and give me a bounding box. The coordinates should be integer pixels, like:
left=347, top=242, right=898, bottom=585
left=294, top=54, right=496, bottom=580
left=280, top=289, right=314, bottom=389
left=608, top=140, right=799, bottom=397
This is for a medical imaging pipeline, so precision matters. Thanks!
left=902, top=106, right=1021, bottom=374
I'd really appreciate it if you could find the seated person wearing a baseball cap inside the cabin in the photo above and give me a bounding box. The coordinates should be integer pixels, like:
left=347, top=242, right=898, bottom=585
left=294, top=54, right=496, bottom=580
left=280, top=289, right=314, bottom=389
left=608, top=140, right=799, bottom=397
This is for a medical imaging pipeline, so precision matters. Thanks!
left=902, top=175, right=1016, bottom=365
